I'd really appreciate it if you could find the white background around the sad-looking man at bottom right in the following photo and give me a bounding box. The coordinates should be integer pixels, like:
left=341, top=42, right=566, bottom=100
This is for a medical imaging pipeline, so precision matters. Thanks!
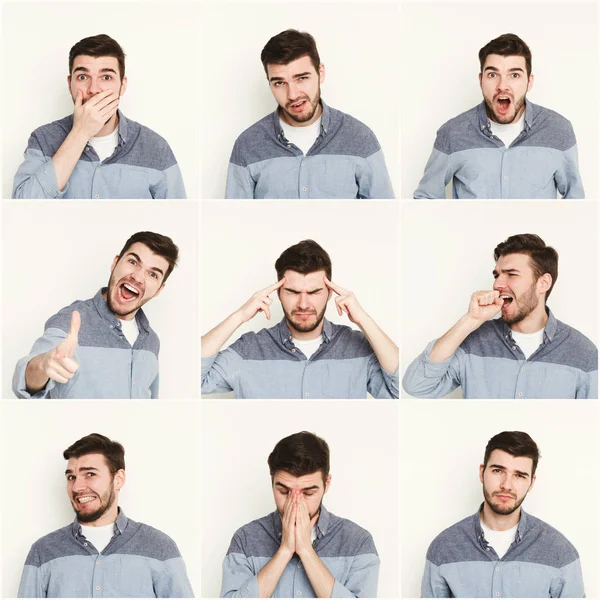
left=400, top=400, right=600, bottom=598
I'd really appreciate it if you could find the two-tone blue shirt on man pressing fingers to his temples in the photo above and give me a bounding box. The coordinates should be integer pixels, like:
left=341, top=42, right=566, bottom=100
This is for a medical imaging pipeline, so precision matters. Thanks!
left=202, top=318, right=400, bottom=399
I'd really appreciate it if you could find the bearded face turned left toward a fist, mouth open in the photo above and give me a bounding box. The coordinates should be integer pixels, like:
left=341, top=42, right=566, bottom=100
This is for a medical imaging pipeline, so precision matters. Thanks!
left=494, top=254, right=547, bottom=325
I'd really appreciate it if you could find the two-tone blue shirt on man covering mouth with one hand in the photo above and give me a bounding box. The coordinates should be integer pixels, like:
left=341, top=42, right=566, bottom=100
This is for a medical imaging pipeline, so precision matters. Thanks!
left=13, top=111, right=186, bottom=199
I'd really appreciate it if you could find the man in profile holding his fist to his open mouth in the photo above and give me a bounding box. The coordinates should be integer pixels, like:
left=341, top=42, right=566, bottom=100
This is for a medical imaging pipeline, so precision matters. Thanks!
left=403, top=233, right=598, bottom=399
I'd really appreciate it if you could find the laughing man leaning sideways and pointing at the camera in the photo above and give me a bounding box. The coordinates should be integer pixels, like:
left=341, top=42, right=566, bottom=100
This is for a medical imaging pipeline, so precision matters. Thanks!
left=13, top=231, right=179, bottom=398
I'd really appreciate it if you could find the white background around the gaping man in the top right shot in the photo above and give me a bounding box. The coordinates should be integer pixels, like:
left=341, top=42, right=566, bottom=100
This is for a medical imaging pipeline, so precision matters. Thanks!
left=400, top=2, right=599, bottom=198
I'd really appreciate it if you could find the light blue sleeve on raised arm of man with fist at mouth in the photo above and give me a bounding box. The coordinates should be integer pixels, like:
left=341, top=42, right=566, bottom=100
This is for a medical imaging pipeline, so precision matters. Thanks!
left=402, top=340, right=465, bottom=398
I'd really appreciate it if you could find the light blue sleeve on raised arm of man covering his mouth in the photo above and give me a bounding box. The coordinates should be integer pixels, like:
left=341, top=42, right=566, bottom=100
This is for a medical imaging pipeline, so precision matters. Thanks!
left=12, top=133, right=69, bottom=199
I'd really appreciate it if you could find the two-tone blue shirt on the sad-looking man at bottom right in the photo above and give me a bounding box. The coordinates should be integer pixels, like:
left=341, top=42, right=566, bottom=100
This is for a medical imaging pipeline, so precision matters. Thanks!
left=421, top=509, right=585, bottom=598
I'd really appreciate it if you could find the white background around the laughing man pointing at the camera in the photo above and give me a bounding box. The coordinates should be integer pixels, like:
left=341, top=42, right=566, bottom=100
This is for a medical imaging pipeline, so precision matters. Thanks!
left=2, top=200, right=200, bottom=399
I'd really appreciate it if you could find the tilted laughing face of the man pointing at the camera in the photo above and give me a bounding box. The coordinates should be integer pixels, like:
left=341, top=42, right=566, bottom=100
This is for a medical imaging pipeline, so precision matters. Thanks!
left=106, top=242, right=169, bottom=320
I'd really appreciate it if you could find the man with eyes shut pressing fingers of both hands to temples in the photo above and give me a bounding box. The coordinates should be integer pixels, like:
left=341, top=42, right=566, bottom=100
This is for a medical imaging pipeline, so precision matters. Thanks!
left=201, top=240, right=399, bottom=398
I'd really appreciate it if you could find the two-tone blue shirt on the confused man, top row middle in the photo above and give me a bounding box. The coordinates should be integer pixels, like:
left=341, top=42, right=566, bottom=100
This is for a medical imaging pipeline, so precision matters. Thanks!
left=225, top=101, right=394, bottom=199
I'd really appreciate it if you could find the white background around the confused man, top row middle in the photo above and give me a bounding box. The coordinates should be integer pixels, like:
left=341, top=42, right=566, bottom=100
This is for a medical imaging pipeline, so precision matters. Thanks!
left=201, top=2, right=400, bottom=198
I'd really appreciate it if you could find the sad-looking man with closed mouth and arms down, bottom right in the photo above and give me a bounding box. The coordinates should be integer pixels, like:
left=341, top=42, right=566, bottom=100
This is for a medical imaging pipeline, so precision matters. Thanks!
left=421, top=431, right=585, bottom=598
